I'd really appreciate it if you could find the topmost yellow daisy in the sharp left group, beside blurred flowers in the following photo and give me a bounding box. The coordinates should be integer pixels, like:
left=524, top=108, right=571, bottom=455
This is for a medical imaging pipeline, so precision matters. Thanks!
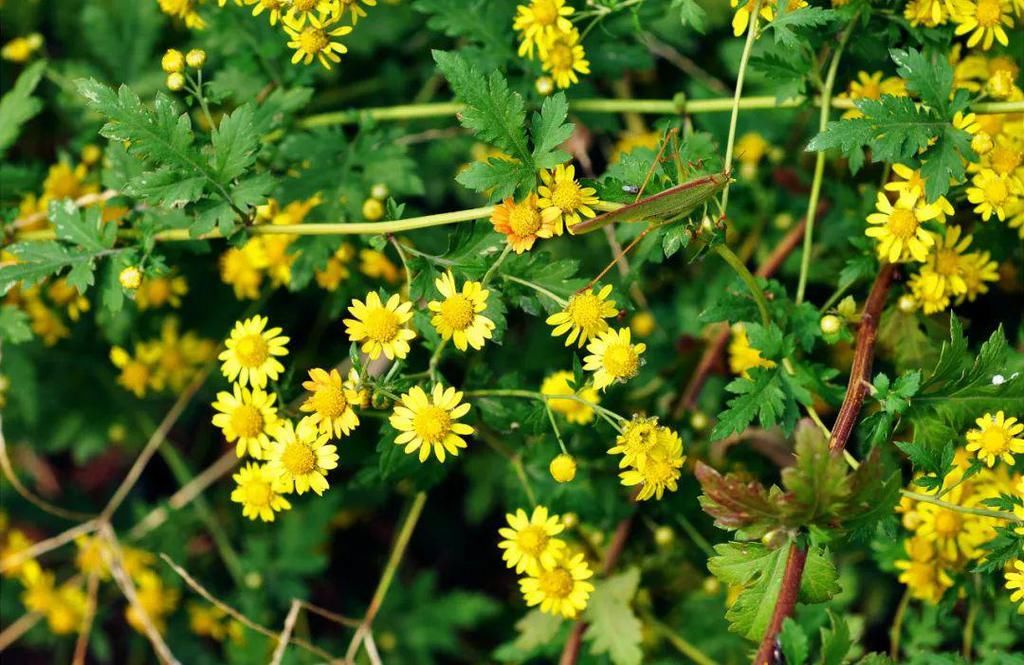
left=217, top=316, right=289, bottom=388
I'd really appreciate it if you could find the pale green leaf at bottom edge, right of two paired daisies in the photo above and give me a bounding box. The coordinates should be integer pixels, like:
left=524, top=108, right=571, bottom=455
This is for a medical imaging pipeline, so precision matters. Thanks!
left=583, top=568, right=643, bottom=665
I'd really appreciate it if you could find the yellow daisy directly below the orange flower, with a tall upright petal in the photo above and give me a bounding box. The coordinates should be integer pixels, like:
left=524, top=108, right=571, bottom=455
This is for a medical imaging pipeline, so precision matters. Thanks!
left=427, top=271, right=495, bottom=351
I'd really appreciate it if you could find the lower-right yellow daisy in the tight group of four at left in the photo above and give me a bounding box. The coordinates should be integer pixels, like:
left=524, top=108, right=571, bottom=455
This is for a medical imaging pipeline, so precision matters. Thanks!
left=267, top=417, right=338, bottom=495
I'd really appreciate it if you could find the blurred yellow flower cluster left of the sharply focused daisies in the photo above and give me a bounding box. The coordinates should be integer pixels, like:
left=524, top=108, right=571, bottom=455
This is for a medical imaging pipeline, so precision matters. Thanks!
left=111, top=317, right=216, bottom=398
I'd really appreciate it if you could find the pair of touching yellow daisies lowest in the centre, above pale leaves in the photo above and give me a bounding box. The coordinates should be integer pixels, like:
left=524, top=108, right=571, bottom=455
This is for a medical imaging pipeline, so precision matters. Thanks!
left=498, top=506, right=594, bottom=619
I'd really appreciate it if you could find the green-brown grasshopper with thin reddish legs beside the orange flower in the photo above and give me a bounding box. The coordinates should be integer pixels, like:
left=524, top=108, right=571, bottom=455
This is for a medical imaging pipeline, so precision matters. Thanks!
left=569, top=128, right=732, bottom=290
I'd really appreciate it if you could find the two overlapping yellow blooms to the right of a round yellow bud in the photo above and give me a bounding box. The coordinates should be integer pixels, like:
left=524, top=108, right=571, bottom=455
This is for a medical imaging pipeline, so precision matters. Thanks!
left=608, top=415, right=685, bottom=501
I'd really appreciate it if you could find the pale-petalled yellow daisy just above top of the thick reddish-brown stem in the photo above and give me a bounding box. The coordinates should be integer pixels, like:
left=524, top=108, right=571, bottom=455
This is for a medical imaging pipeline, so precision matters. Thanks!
left=864, top=191, right=939, bottom=263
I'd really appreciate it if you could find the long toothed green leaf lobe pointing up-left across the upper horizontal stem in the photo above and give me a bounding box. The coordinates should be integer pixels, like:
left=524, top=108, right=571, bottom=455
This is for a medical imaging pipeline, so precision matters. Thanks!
left=433, top=50, right=530, bottom=164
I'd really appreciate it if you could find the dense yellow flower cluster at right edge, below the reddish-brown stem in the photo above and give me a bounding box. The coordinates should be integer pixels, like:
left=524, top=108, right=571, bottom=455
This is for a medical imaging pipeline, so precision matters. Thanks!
left=896, top=422, right=1024, bottom=604
